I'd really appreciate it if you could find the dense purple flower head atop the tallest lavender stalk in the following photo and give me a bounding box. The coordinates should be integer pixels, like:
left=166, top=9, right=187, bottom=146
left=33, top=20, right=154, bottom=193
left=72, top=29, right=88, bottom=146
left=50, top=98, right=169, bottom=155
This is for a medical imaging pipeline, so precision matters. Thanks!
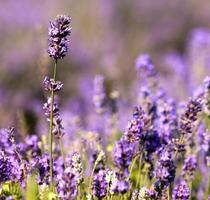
left=48, top=15, right=71, bottom=60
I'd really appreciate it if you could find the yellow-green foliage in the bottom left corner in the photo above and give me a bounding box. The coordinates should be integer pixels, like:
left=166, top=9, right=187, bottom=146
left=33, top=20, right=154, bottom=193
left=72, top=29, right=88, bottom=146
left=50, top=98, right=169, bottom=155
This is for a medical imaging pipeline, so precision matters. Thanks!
left=0, top=182, right=23, bottom=200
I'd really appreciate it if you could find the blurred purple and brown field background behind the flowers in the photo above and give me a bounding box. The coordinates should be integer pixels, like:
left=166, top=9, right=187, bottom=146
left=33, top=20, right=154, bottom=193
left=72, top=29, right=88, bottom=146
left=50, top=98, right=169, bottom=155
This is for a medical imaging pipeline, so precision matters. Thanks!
left=0, top=0, right=210, bottom=131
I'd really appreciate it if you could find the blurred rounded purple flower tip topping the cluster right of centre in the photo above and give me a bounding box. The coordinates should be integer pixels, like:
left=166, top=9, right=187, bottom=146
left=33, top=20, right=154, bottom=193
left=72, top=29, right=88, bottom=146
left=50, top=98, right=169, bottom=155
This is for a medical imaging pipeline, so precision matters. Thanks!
left=135, top=54, right=154, bottom=76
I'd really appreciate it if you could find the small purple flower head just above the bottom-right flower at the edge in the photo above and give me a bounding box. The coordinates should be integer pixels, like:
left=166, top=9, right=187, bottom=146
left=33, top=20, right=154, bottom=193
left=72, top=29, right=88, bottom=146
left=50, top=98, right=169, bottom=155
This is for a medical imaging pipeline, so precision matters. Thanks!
left=182, top=155, right=197, bottom=180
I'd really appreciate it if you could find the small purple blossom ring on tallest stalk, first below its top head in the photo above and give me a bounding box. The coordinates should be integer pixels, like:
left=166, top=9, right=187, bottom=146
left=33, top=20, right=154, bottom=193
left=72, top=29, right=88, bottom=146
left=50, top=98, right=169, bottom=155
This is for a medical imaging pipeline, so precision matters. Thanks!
left=43, top=76, right=63, bottom=92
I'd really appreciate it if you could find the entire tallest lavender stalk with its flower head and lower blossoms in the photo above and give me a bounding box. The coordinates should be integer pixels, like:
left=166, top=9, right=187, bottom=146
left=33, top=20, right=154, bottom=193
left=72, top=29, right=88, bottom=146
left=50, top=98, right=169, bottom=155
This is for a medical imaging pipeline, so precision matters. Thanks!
left=44, top=15, right=71, bottom=191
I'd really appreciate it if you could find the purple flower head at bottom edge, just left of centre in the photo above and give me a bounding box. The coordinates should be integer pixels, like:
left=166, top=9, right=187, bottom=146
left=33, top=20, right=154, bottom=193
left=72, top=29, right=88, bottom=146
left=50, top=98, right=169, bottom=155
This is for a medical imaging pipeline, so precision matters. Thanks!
left=92, top=170, right=108, bottom=199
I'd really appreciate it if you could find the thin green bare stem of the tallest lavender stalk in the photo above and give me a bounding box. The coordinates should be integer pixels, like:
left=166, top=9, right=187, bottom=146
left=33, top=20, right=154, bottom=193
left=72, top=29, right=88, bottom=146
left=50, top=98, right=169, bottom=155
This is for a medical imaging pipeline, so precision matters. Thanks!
left=49, top=60, right=57, bottom=192
